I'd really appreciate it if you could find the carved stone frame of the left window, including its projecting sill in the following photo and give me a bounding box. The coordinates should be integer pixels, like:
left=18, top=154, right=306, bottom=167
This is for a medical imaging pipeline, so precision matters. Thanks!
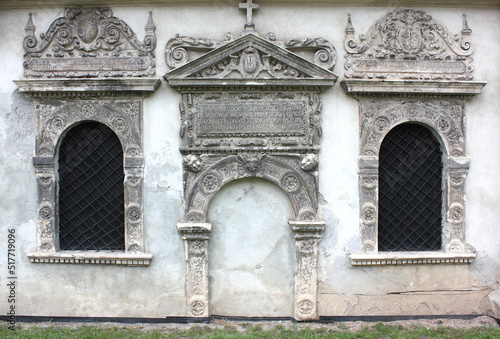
left=28, top=94, right=152, bottom=266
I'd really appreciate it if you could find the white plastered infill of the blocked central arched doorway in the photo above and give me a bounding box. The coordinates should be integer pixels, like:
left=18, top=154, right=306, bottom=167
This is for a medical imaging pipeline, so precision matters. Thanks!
left=208, top=179, right=295, bottom=316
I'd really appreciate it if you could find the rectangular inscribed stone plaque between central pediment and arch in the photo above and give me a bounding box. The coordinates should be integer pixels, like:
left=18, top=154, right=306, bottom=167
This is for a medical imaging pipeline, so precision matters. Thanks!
left=198, top=100, right=307, bottom=137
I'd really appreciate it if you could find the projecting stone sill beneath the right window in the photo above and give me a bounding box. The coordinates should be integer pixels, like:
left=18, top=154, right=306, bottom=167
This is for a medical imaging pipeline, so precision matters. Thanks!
left=349, top=252, right=476, bottom=266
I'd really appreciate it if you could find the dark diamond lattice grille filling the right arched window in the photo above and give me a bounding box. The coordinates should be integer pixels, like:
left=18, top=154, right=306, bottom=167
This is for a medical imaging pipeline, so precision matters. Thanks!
left=378, top=124, right=443, bottom=251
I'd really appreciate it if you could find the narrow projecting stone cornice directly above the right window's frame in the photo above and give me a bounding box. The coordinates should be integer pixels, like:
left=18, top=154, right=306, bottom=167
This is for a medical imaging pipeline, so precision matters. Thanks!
left=341, top=79, right=486, bottom=96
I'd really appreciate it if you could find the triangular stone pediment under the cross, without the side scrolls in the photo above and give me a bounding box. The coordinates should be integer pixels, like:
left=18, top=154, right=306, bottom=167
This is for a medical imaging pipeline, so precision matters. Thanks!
left=164, top=33, right=337, bottom=85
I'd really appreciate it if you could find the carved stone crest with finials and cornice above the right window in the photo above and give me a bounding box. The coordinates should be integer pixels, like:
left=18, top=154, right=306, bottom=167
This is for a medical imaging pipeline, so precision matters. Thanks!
left=342, top=9, right=485, bottom=95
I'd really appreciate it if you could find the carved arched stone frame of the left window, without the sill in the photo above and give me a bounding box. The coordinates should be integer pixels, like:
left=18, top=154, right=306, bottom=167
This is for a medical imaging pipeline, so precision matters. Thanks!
left=33, top=98, right=144, bottom=253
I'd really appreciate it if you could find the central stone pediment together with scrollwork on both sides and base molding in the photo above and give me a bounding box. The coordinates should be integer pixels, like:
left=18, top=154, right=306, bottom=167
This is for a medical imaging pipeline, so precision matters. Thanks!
left=164, top=33, right=337, bottom=93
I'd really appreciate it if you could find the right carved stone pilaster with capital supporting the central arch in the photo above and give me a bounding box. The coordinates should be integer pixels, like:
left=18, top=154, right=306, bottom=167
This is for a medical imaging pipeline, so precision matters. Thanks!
left=289, top=220, right=325, bottom=320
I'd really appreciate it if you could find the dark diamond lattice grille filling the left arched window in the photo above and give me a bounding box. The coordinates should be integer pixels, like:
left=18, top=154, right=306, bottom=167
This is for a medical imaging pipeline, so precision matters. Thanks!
left=59, top=122, right=125, bottom=250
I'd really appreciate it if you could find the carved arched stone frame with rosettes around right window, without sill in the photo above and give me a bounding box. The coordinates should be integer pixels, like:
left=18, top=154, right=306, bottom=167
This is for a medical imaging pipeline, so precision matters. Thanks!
left=358, top=98, right=469, bottom=253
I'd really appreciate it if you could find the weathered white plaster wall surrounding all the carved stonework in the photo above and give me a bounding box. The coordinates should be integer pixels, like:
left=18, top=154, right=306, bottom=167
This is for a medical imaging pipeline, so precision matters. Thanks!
left=0, top=3, right=500, bottom=317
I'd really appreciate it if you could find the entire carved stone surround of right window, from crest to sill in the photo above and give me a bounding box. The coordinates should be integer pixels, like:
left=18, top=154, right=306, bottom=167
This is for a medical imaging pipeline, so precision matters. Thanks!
left=343, top=9, right=485, bottom=265
